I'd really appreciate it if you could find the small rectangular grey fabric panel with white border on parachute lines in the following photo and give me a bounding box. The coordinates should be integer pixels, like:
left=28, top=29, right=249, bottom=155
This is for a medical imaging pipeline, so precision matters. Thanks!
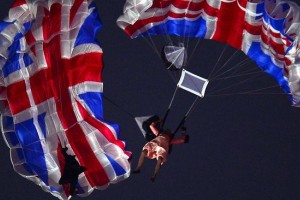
left=177, top=70, right=208, bottom=97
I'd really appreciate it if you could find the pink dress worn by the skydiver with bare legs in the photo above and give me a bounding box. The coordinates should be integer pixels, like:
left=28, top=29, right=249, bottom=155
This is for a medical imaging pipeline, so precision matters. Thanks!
left=143, top=133, right=170, bottom=163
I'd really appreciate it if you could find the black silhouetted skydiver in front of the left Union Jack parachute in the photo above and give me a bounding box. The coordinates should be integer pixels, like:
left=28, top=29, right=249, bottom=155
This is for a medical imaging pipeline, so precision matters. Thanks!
left=58, top=147, right=86, bottom=196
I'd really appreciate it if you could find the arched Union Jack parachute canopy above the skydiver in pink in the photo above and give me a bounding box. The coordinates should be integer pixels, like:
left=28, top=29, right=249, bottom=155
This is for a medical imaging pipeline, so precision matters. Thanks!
left=117, top=0, right=300, bottom=106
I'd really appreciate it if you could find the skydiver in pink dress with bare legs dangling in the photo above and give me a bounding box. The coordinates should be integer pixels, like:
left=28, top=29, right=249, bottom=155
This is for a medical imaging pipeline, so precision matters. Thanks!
left=132, top=119, right=189, bottom=182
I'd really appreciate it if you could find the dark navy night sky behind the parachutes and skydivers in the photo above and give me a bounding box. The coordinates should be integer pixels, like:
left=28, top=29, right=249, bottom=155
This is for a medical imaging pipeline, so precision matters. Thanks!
left=0, top=0, right=300, bottom=200
